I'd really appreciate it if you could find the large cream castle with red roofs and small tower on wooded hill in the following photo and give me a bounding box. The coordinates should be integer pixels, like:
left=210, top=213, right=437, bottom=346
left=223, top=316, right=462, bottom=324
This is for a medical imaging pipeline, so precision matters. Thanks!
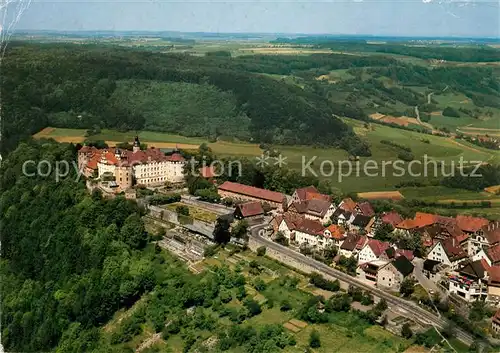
left=78, top=137, right=186, bottom=190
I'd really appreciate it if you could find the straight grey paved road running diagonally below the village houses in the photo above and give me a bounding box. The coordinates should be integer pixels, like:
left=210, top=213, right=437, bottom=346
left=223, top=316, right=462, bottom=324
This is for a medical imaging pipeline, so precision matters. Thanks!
left=250, top=225, right=473, bottom=345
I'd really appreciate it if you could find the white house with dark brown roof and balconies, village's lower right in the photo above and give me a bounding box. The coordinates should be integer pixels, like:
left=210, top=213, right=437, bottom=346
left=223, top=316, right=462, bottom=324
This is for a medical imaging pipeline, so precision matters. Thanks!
left=449, top=260, right=488, bottom=302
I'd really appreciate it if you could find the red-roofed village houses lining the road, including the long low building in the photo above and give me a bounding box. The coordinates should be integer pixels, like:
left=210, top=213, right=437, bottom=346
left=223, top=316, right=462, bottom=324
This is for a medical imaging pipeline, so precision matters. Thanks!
left=213, top=182, right=500, bottom=304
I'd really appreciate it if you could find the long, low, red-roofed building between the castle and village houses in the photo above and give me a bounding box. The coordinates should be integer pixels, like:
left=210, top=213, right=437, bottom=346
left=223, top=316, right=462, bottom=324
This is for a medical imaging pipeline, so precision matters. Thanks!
left=217, top=181, right=285, bottom=210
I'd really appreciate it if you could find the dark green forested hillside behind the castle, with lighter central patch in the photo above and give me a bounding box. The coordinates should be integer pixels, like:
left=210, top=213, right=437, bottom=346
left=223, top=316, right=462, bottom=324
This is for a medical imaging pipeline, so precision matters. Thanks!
left=2, top=43, right=369, bottom=155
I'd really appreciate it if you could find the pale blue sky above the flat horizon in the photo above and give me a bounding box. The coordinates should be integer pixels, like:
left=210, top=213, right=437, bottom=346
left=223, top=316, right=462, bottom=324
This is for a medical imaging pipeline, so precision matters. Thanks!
left=2, top=0, right=500, bottom=37
